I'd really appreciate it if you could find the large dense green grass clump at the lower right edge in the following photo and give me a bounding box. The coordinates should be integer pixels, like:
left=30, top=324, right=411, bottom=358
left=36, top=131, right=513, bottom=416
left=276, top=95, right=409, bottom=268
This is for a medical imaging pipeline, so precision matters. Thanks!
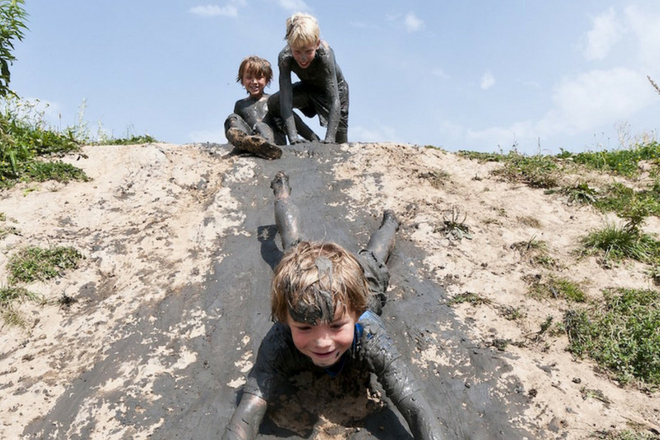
left=564, top=289, right=660, bottom=386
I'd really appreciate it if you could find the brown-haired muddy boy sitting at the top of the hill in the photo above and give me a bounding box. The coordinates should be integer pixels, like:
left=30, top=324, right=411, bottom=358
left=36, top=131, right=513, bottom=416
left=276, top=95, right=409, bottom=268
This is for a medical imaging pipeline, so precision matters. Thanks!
left=225, top=56, right=319, bottom=159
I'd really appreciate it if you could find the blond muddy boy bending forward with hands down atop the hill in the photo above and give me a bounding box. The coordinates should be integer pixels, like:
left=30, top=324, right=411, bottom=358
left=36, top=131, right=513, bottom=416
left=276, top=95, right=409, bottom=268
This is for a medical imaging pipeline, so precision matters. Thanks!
left=268, top=13, right=348, bottom=144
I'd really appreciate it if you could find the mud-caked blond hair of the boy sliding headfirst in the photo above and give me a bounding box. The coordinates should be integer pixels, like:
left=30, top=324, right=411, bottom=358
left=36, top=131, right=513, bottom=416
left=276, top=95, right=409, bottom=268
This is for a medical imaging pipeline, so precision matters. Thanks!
left=271, top=241, right=369, bottom=325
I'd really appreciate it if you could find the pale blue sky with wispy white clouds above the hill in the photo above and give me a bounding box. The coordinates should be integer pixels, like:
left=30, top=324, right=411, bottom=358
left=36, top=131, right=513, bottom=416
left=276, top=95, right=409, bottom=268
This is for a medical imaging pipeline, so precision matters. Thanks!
left=10, top=0, right=660, bottom=154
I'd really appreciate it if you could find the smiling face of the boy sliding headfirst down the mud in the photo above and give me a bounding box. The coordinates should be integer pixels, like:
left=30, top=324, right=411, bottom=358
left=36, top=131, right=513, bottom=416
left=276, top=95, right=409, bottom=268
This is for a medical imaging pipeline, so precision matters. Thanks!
left=287, top=311, right=357, bottom=368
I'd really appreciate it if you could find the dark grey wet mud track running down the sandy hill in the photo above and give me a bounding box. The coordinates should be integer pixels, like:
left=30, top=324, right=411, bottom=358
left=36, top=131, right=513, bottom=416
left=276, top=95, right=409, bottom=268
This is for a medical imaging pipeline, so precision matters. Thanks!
left=24, top=143, right=534, bottom=440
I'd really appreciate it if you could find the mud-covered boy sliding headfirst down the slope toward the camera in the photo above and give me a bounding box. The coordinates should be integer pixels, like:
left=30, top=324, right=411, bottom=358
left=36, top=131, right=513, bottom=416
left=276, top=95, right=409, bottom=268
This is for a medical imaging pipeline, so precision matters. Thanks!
left=222, top=171, right=442, bottom=440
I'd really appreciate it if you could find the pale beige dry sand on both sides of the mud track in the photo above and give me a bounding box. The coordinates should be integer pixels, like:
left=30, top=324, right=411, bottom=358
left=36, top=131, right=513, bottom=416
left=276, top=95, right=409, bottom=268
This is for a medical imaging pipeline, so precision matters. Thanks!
left=0, top=144, right=660, bottom=440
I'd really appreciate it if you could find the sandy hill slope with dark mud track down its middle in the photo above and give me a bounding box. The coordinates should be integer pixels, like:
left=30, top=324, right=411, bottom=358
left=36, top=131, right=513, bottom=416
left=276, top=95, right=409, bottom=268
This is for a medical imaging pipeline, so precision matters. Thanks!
left=0, top=144, right=660, bottom=440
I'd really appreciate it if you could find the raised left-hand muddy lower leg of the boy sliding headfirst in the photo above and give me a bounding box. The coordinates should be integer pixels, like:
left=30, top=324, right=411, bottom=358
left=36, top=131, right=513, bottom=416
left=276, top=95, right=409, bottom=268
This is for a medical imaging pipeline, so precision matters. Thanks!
left=270, top=171, right=302, bottom=250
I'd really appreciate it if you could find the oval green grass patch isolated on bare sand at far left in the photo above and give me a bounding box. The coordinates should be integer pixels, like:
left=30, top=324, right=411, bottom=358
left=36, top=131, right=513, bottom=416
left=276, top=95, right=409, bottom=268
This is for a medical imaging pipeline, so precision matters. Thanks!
left=7, top=246, right=84, bottom=285
